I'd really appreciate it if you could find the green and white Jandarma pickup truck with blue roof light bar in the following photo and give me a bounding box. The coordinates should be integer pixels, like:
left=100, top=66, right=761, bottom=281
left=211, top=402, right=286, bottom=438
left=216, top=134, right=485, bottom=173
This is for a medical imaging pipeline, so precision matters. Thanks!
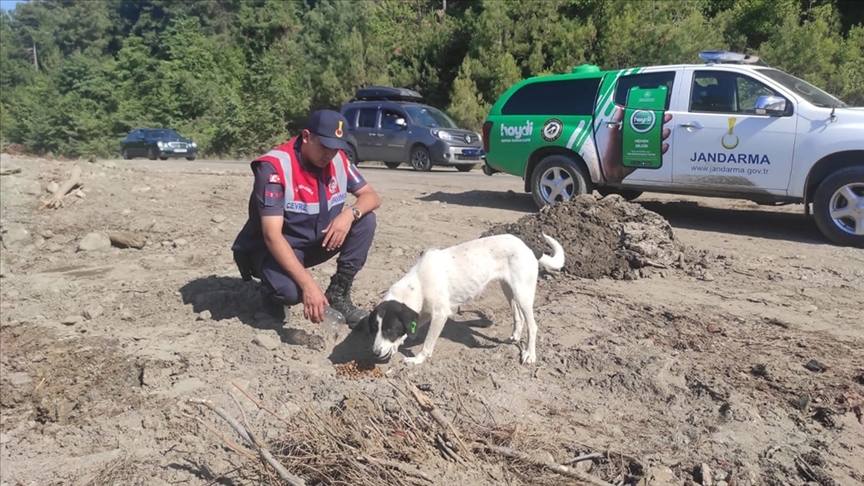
left=483, top=51, right=864, bottom=247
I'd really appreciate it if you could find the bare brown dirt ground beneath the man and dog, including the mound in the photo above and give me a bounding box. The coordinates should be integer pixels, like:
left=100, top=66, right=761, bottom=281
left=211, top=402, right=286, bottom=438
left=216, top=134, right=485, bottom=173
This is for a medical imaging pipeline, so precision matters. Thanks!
left=0, top=154, right=864, bottom=486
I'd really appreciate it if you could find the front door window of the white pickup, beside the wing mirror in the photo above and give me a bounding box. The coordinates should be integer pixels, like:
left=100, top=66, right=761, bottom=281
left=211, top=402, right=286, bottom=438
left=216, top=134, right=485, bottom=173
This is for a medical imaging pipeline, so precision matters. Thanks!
left=690, top=71, right=778, bottom=114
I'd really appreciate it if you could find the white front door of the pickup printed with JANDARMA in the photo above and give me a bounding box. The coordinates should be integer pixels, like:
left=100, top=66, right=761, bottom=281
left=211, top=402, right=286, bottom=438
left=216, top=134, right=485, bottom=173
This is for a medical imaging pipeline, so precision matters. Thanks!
left=672, top=66, right=798, bottom=194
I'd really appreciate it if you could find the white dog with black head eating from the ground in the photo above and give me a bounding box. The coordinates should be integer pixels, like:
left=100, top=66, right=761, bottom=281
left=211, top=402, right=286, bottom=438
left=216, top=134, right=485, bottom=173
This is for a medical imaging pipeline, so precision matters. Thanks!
left=367, top=234, right=564, bottom=364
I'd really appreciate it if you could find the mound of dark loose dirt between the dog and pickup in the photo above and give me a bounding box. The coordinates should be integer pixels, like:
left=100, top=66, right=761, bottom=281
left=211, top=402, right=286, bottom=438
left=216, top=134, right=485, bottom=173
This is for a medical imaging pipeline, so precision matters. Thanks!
left=483, top=194, right=700, bottom=280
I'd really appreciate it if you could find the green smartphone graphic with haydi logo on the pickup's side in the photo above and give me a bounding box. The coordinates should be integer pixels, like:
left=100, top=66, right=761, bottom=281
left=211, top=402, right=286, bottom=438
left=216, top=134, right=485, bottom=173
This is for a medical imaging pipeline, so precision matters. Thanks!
left=621, top=85, right=668, bottom=169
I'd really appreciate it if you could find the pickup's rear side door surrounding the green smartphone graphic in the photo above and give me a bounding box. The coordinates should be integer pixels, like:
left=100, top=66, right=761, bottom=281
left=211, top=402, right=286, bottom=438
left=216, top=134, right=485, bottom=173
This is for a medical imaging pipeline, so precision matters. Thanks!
left=594, top=67, right=682, bottom=187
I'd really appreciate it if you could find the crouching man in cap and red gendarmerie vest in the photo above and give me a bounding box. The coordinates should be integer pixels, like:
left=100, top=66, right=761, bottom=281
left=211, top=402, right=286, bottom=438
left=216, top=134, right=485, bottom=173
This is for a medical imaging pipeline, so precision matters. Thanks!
left=231, top=110, right=381, bottom=328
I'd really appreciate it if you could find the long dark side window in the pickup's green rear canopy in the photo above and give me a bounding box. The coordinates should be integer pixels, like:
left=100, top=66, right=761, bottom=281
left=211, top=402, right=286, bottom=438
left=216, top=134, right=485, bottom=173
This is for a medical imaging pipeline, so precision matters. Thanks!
left=501, top=77, right=601, bottom=116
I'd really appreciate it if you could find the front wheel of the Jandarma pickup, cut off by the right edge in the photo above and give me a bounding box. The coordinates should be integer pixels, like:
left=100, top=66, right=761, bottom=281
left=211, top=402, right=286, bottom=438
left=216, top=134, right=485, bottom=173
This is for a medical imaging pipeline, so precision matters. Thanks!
left=813, top=167, right=864, bottom=248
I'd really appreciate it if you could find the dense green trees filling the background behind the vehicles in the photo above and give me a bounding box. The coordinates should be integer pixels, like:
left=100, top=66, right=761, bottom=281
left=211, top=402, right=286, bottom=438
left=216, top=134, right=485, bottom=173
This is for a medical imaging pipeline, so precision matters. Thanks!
left=0, top=0, right=864, bottom=157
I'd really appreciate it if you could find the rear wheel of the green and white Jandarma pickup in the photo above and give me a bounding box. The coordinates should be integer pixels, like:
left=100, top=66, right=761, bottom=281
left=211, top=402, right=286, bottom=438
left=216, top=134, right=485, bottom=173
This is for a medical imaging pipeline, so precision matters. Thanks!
left=531, top=154, right=589, bottom=208
